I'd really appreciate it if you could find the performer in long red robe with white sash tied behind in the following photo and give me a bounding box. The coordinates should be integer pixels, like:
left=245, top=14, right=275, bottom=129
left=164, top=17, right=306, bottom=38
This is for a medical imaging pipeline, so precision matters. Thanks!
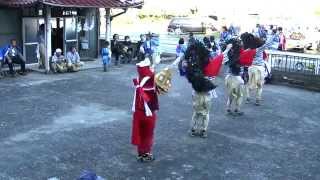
left=132, top=58, right=159, bottom=162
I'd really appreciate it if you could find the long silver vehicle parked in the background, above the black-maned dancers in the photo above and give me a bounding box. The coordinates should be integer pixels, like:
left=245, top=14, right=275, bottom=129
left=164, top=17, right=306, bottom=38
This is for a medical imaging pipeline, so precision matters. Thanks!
left=168, top=17, right=217, bottom=33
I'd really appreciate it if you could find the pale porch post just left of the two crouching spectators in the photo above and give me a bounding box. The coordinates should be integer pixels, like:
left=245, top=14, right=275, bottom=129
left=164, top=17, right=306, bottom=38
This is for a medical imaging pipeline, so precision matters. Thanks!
left=44, top=6, right=52, bottom=73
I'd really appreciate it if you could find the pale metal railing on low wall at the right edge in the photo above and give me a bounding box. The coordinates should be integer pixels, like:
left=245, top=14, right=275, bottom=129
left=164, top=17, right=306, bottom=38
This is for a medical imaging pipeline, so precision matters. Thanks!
left=267, top=51, right=320, bottom=76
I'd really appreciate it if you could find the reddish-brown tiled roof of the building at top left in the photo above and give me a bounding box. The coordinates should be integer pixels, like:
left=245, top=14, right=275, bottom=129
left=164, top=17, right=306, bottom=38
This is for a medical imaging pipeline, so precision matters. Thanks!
left=0, top=0, right=143, bottom=8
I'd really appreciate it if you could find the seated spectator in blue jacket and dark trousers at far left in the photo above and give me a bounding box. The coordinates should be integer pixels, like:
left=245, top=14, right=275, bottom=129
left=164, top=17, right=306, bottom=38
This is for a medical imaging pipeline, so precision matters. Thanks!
left=3, top=39, right=26, bottom=76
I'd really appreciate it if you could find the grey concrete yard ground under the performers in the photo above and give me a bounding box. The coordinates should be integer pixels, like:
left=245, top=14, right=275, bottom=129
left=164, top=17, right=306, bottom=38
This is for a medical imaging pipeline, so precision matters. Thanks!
left=0, top=65, right=320, bottom=180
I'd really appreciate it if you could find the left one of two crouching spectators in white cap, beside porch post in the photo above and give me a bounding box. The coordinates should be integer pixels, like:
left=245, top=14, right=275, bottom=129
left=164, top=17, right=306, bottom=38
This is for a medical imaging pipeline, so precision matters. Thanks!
left=50, top=48, right=67, bottom=73
